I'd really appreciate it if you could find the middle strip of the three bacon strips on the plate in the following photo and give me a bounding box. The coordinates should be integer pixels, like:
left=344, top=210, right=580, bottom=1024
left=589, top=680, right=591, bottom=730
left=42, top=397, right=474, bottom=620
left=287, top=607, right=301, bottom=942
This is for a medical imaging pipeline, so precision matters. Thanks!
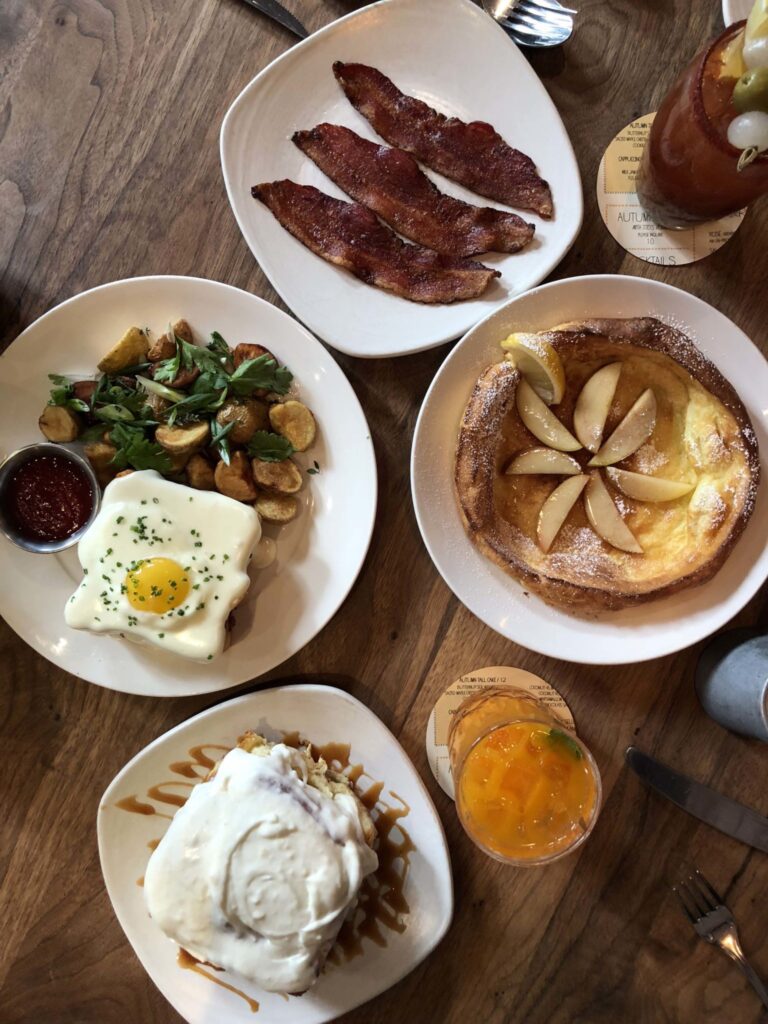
left=293, top=124, right=534, bottom=256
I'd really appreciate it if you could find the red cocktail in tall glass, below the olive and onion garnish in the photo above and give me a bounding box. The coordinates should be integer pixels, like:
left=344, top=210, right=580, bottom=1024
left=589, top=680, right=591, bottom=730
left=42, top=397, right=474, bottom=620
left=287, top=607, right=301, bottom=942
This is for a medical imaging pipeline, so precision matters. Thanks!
left=637, top=22, right=768, bottom=227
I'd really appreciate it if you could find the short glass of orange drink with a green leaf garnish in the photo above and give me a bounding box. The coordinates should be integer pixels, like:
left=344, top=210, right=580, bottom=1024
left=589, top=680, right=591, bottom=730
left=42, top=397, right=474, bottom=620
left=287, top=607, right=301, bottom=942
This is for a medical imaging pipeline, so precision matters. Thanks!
left=449, top=687, right=602, bottom=866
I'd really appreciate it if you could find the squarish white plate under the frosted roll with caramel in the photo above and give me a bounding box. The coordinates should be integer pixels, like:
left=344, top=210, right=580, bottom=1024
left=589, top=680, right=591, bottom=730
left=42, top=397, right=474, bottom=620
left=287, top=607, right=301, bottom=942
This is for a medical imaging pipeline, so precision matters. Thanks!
left=98, top=685, right=454, bottom=1024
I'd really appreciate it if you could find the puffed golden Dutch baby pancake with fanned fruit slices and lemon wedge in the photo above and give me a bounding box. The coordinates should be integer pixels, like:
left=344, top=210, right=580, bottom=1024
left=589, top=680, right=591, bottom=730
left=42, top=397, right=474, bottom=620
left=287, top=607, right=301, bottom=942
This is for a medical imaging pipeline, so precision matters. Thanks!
left=456, top=317, right=760, bottom=615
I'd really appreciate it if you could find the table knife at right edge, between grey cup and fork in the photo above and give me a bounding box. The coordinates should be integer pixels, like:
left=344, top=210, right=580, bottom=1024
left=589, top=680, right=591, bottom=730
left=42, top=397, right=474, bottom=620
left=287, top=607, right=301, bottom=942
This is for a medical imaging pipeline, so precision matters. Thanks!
left=625, top=746, right=768, bottom=853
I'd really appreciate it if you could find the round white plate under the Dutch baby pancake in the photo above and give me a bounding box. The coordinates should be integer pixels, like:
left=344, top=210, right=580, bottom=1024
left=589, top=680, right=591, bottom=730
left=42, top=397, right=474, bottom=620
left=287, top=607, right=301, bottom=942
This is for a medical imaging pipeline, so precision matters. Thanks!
left=411, top=274, right=768, bottom=665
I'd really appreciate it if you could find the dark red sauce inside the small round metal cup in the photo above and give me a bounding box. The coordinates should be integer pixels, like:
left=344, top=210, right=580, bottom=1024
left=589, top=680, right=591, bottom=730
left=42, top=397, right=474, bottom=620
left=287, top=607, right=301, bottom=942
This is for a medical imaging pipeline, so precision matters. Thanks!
left=3, top=455, right=94, bottom=542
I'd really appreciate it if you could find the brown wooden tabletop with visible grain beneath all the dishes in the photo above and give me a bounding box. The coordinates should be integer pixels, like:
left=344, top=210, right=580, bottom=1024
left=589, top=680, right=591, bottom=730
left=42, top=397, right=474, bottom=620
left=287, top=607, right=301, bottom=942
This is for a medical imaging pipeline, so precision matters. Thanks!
left=0, top=0, right=768, bottom=1024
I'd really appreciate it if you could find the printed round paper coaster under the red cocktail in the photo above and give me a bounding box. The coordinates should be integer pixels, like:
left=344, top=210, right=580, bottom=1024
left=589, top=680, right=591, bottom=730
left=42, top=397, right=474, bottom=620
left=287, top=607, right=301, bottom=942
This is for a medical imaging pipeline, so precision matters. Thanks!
left=597, top=113, right=746, bottom=266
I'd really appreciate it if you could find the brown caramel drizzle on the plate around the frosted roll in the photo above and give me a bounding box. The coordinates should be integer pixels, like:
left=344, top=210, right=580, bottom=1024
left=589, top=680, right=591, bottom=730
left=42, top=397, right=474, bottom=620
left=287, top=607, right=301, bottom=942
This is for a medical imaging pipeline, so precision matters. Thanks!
left=115, top=732, right=416, bottom=1013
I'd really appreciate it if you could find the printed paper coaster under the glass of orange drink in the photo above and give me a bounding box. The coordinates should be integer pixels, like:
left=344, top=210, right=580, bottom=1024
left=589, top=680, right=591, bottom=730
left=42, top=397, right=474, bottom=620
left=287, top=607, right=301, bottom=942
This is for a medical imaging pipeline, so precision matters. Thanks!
left=427, top=666, right=573, bottom=800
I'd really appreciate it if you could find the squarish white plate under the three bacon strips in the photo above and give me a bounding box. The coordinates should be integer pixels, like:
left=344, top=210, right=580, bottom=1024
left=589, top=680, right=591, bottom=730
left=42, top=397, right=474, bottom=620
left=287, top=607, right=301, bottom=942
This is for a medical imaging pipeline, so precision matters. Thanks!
left=221, top=0, right=582, bottom=357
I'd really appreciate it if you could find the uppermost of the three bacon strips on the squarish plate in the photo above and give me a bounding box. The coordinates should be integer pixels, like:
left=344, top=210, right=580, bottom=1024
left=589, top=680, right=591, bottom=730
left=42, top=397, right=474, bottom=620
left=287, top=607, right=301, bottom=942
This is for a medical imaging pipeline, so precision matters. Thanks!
left=334, top=60, right=552, bottom=219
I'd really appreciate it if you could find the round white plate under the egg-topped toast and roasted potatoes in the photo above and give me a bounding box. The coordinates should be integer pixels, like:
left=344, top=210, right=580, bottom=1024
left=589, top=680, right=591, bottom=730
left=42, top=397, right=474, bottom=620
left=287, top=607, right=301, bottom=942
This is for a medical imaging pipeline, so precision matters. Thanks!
left=0, top=278, right=377, bottom=696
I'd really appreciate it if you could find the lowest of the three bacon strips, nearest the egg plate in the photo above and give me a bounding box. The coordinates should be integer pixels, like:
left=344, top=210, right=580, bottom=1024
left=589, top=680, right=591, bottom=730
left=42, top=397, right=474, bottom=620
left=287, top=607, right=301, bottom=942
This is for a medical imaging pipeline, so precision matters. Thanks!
left=251, top=180, right=500, bottom=302
